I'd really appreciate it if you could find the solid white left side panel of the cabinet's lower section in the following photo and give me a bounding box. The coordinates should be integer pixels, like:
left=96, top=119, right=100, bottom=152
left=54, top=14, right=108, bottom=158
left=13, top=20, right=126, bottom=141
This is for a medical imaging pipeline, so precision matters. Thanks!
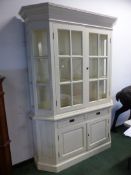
left=35, top=121, right=56, bottom=164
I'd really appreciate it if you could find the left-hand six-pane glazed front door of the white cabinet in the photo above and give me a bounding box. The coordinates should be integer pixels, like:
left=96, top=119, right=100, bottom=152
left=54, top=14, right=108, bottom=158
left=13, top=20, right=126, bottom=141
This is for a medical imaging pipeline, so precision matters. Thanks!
left=53, top=24, right=88, bottom=113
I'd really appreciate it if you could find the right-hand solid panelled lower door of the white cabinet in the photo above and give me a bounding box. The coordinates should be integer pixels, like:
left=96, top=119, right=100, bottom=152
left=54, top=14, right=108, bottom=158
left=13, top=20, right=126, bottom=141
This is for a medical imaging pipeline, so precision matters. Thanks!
left=87, top=118, right=110, bottom=150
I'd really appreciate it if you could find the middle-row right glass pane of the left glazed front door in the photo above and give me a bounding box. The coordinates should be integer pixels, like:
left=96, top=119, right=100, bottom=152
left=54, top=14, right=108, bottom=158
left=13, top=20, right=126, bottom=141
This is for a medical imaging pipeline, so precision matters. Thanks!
left=72, top=58, right=83, bottom=81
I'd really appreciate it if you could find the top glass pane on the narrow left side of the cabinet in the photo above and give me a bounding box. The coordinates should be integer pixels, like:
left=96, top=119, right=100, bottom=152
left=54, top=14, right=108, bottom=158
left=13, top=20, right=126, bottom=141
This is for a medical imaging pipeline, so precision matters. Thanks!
left=33, top=30, right=48, bottom=56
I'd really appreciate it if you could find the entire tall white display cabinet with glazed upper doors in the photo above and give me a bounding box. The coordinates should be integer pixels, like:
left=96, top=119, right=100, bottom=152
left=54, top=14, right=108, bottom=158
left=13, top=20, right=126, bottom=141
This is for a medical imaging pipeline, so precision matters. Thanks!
left=20, top=3, right=116, bottom=172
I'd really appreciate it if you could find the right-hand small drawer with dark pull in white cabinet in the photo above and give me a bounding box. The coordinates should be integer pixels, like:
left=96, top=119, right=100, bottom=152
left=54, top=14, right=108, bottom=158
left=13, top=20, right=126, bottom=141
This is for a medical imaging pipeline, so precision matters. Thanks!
left=86, top=108, right=110, bottom=120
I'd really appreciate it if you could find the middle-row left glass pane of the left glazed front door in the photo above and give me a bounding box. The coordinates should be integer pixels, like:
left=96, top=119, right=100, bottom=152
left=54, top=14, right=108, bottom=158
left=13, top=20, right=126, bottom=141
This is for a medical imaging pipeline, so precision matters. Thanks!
left=59, top=58, right=71, bottom=82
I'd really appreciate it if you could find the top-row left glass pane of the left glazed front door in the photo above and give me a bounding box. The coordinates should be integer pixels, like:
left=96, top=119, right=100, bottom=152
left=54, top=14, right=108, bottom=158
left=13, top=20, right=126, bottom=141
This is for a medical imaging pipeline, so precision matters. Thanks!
left=58, top=30, right=70, bottom=55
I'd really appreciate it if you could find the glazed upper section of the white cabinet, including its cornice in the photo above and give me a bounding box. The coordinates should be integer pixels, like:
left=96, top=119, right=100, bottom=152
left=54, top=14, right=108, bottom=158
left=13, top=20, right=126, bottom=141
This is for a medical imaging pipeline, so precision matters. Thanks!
left=20, top=3, right=116, bottom=118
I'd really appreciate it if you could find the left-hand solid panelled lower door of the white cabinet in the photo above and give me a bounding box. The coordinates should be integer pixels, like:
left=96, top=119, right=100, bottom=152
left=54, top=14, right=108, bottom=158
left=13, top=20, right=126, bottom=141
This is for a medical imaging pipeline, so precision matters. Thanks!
left=58, top=124, right=86, bottom=160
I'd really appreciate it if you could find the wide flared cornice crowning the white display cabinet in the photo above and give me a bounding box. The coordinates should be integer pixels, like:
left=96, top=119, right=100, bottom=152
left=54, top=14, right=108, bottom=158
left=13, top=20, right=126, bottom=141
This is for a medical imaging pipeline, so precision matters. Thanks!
left=19, top=3, right=116, bottom=29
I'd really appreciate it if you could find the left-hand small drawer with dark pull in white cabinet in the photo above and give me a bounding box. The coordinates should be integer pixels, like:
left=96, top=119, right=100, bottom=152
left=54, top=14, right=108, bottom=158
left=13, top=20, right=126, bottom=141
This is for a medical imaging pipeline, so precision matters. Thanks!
left=57, top=115, right=85, bottom=128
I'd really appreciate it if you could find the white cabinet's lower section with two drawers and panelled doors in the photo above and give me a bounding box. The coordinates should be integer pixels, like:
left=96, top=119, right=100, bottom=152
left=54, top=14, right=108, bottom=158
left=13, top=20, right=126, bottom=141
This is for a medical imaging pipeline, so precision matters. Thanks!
left=34, top=106, right=111, bottom=172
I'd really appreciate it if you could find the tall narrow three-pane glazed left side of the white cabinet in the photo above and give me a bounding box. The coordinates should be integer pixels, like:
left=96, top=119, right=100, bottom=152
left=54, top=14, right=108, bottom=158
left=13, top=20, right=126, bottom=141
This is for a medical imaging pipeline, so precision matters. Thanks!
left=28, top=22, right=52, bottom=116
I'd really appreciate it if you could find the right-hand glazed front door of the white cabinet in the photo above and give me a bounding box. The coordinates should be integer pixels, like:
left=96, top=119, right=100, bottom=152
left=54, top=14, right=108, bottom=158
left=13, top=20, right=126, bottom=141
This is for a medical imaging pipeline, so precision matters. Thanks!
left=89, top=29, right=111, bottom=102
